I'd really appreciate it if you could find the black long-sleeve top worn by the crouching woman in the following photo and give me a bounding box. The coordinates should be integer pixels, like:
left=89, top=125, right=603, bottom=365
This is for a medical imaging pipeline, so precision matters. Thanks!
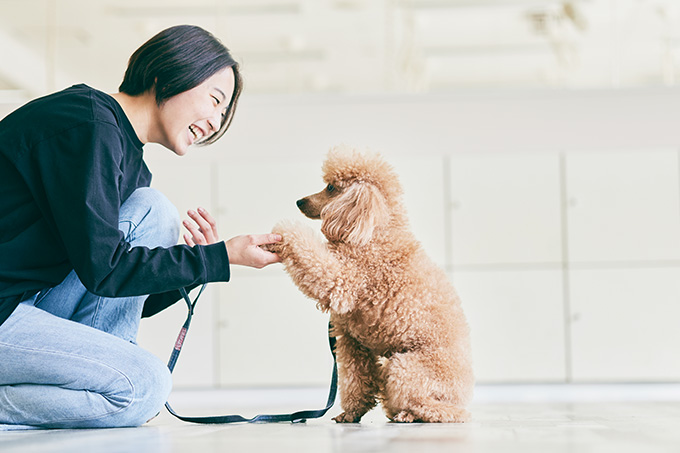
left=0, top=85, right=230, bottom=324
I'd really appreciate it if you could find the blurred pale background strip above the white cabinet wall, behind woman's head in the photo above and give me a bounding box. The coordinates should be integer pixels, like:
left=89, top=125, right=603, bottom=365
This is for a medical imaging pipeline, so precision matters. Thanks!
left=0, top=0, right=680, bottom=101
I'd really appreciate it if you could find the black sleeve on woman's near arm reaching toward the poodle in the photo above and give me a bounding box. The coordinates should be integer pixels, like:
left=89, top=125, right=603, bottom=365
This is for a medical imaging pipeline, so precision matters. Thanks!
left=32, top=123, right=229, bottom=297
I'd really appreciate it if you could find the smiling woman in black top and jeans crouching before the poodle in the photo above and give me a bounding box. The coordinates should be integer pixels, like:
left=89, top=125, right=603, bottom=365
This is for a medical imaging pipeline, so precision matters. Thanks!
left=0, top=26, right=280, bottom=429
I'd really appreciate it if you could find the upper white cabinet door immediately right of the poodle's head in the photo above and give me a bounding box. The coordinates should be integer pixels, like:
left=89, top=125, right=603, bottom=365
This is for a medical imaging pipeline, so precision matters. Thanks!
left=451, top=152, right=562, bottom=266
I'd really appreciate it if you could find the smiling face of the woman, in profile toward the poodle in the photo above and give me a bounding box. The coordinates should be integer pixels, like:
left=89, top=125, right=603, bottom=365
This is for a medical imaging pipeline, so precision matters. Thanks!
left=153, top=67, right=235, bottom=156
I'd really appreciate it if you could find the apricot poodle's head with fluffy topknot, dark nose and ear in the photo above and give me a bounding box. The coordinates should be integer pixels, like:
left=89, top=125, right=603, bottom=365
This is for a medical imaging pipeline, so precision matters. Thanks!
left=297, top=147, right=401, bottom=246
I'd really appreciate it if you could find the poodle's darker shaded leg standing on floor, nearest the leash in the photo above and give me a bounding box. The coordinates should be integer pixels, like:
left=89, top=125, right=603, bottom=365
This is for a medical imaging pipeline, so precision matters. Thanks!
left=333, top=335, right=378, bottom=423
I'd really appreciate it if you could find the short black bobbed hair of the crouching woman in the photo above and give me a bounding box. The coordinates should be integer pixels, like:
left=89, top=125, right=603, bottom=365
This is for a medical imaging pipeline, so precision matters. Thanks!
left=118, top=25, right=243, bottom=145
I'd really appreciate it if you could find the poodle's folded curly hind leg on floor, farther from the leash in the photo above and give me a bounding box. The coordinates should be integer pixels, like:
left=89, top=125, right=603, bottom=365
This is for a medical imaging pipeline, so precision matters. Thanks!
left=382, top=351, right=473, bottom=423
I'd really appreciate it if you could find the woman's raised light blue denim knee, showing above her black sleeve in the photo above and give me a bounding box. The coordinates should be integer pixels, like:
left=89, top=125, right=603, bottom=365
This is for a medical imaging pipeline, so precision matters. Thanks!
left=119, top=187, right=180, bottom=248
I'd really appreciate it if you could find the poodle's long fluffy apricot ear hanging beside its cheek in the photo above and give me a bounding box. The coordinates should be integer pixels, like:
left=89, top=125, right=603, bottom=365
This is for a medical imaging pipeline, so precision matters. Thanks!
left=321, top=183, right=390, bottom=246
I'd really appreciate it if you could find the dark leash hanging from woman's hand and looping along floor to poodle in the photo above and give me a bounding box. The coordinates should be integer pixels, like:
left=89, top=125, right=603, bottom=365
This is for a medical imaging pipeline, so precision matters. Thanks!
left=165, top=284, right=338, bottom=424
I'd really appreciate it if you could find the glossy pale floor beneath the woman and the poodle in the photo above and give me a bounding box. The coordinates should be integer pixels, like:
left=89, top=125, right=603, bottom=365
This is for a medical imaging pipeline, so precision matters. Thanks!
left=0, top=386, right=680, bottom=453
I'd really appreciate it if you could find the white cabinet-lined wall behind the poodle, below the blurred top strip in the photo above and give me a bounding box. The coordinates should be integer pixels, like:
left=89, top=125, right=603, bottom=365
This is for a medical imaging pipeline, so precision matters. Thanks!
left=5, top=86, right=680, bottom=387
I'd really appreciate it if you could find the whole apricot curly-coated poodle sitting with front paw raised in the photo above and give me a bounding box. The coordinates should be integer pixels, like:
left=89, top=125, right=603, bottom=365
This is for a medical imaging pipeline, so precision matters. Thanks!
left=270, top=147, right=474, bottom=423
